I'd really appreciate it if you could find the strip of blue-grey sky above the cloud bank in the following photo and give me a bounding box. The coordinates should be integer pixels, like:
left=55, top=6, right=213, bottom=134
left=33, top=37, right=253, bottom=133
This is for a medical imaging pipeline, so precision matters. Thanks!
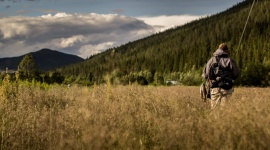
left=0, top=0, right=242, bottom=17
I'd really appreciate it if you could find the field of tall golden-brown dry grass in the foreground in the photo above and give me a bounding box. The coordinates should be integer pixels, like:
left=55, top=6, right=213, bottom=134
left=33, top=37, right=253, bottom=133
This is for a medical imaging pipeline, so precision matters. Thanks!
left=0, top=83, right=270, bottom=150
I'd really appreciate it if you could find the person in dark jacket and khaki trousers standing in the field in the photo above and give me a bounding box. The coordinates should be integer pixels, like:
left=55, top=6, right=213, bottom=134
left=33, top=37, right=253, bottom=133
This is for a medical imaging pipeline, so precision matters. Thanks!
left=203, top=43, right=239, bottom=109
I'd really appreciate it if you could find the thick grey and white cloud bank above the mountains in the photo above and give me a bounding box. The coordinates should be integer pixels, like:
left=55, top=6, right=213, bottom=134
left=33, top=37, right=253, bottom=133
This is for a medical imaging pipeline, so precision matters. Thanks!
left=0, top=13, right=202, bottom=58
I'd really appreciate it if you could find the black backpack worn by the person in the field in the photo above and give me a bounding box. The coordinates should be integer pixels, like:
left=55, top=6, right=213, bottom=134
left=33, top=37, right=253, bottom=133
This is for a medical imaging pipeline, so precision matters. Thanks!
left=209, top=56, right=233, bottom=90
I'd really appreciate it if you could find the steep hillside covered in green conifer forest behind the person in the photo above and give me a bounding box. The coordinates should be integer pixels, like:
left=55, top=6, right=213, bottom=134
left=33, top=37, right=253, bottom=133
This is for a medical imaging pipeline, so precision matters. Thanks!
left=57, top=0, right=270, bottom=86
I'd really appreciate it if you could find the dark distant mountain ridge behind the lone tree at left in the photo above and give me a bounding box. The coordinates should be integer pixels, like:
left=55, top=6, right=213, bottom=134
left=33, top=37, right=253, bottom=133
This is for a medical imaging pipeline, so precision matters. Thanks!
left=0, top=49, right=84, bottom=71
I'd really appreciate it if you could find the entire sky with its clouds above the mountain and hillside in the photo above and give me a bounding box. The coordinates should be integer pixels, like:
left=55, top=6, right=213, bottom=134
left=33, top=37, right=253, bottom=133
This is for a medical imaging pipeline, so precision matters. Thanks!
left=0, top=0, right=242, bottom=58
